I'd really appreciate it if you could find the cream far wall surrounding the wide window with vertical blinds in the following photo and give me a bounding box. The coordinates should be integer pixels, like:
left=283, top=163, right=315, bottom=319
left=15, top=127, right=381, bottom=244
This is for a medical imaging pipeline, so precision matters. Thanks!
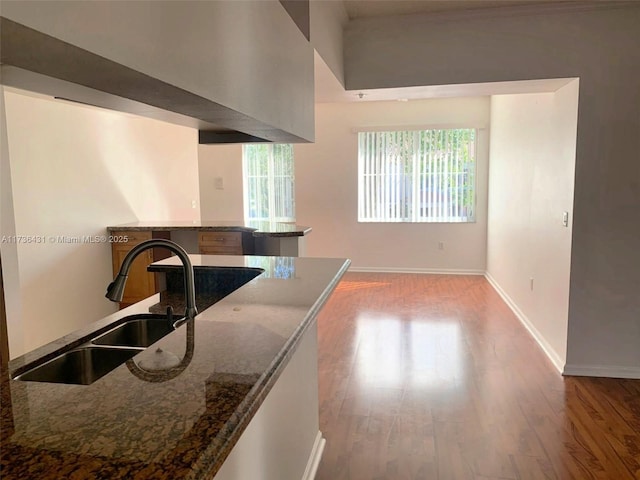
left=295, top=97, right=489, bottom=272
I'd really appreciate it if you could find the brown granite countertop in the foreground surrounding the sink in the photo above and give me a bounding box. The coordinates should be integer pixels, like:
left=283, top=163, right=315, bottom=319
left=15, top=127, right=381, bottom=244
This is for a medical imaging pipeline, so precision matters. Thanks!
left=0, top=255, right=349, bottom=480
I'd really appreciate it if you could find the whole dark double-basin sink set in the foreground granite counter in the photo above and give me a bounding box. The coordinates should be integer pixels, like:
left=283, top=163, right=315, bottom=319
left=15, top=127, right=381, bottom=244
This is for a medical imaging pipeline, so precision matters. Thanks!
left=14, top=314, right=182, bottom=385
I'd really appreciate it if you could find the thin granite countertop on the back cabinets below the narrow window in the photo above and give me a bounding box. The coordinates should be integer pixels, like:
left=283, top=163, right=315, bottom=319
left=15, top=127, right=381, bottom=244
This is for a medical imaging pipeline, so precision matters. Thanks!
left=107, top=220, right=311, bottom=237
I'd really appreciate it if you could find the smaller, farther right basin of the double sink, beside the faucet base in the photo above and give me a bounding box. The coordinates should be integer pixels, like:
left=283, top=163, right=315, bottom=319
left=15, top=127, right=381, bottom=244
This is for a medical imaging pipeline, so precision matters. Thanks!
left=91, top=314, right=180, bottom=347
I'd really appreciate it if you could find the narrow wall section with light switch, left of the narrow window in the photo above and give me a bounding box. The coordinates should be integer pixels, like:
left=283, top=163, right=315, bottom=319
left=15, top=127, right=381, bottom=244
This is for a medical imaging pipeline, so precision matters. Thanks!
left=198, top=144, right=244, bottom=221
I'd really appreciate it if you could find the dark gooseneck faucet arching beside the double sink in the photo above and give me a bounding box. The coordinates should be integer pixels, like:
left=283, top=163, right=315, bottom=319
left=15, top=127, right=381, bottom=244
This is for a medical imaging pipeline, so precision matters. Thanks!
left=105, top=238, right=198, bottom=327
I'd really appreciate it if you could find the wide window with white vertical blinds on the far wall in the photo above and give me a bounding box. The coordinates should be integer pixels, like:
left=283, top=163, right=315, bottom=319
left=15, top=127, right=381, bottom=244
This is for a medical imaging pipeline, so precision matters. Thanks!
left=358, top=129, right=477, bottom=222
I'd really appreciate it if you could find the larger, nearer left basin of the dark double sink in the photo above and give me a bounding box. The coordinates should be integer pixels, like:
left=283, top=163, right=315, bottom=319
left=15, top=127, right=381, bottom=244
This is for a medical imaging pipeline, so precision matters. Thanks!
left=15, top=347, right=143, bottom=385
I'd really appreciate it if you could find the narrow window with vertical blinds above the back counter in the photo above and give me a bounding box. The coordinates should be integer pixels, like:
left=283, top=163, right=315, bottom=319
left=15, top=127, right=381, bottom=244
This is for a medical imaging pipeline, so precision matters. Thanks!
left=242, top=143, right=295, bottom=222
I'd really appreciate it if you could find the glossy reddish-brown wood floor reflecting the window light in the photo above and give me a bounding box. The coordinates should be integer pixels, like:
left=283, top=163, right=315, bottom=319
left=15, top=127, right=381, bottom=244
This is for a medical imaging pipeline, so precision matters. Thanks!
left=316, top=273, right=640, bottom=480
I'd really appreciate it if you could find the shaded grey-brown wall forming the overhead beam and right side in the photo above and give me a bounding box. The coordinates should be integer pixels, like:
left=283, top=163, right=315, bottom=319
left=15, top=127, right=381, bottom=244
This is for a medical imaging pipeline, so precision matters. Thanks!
left=344, top=2, right=640, bottom=378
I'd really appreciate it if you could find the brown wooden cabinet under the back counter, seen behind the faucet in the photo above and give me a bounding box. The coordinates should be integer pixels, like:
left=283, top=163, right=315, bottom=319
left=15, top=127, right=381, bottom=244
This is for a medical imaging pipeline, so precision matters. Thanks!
left=111, top=231, right=171, bottom=308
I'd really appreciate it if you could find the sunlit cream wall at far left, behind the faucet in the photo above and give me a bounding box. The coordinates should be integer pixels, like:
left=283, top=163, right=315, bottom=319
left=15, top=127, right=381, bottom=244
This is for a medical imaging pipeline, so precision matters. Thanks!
left=2, top=90, right=200, bottom=358
